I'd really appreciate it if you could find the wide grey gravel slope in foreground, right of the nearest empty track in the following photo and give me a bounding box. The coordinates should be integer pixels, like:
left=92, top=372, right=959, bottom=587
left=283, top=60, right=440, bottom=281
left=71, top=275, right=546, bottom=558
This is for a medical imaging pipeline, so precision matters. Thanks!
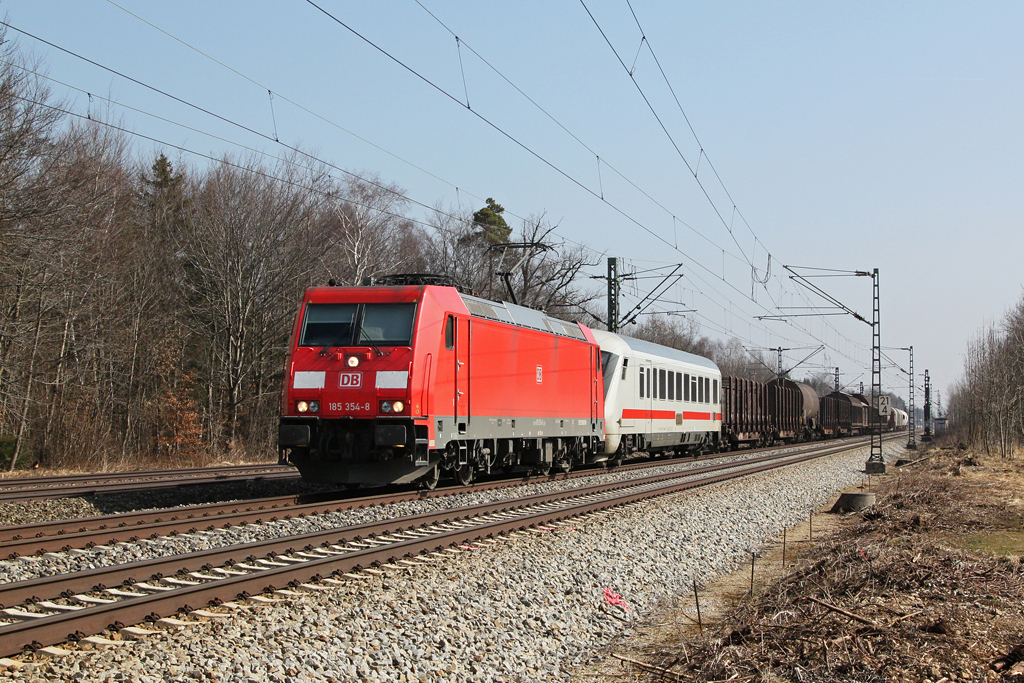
left=5, top=444, right=903, bottom=683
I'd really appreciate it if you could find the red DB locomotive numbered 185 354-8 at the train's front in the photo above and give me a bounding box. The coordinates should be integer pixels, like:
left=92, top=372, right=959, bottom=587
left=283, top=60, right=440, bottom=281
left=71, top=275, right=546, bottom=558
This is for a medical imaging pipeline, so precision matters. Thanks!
left=279, top=285, right=604, bottom=487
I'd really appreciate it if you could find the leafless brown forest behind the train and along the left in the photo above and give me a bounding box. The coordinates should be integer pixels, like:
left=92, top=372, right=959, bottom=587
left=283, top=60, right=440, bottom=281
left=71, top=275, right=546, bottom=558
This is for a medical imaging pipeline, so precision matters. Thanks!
left=0, top=36, right=872, bottom=469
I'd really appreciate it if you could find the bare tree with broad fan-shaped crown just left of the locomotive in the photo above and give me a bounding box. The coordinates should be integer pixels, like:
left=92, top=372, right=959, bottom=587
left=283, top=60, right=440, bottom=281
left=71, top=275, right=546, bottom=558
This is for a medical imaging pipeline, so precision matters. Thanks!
left=173, top=158, right=329, bottom=450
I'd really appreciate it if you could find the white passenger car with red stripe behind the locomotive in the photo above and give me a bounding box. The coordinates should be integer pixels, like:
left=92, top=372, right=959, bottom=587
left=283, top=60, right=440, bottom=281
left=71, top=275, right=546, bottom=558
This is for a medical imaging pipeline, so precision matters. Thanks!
left=593, top=330, right=722, bottom=461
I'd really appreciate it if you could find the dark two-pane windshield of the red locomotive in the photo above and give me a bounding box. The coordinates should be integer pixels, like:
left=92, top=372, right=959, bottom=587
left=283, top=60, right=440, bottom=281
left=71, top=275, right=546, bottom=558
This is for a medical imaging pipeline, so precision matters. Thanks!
left=299, top=303, right=416, bottom=348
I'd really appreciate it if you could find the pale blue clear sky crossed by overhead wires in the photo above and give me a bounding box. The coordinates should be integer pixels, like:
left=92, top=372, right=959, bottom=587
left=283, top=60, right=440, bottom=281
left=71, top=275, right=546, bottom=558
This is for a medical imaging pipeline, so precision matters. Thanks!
left=0, top=0, right=1024, bottom=405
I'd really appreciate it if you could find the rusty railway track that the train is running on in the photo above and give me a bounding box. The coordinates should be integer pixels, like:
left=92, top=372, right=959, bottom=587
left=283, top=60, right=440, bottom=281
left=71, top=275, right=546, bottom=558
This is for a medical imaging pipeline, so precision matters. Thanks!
left=0, top=439, right=880, bottom=559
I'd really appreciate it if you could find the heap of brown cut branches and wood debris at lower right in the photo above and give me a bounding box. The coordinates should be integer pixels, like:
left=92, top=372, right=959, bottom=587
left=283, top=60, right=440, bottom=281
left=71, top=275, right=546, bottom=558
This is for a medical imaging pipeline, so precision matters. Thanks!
left=631, top=458, right=1024, bottom=683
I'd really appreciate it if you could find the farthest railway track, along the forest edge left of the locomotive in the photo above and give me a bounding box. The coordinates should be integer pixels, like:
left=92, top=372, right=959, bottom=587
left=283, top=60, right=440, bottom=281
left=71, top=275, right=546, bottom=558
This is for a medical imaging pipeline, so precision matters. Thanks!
left=0, top=464, right=299, bottom=503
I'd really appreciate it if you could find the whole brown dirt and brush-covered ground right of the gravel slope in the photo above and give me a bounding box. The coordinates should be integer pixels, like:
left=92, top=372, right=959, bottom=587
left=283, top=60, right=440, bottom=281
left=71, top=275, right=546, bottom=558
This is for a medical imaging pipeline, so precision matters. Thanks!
left=573, top=445, right=1024, bottom=683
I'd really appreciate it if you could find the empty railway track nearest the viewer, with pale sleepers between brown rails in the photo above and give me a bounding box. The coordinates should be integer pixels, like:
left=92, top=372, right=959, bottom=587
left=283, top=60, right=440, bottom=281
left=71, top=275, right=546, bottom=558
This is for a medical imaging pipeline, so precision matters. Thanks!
left=0, top=443, right=880, bottom=656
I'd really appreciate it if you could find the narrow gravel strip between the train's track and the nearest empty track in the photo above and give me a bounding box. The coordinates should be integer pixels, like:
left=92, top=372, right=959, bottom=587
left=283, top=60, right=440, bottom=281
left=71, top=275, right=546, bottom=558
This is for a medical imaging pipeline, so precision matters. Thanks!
left=0, top=446, right=839, bottom=583
